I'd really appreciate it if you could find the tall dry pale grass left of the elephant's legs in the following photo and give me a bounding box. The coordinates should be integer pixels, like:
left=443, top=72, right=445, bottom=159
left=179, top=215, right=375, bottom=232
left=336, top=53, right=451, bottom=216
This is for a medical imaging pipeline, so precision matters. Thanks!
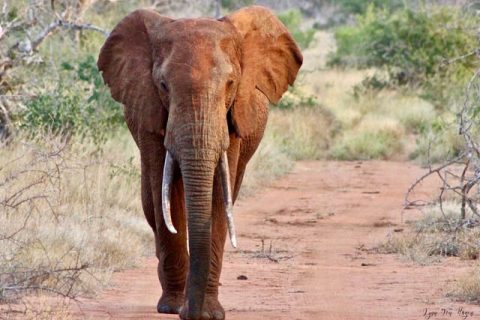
left=0, top=133, right=152, bottom=306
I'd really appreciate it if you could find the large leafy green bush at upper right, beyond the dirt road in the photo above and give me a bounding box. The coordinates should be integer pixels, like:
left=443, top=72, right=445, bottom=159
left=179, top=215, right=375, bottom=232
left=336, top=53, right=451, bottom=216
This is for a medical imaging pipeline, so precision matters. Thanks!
left=328, top=5, right=478, bottom=106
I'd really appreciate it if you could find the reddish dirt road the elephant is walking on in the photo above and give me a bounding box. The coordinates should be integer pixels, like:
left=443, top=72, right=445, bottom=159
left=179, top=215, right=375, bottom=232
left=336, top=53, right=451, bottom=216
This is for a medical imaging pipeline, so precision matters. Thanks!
left=75, top=161, right=480, bottom=320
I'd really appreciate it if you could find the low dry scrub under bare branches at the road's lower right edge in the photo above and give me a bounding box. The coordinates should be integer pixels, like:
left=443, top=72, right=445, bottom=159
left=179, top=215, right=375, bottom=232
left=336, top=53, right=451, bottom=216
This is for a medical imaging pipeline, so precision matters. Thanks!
left=374, top=199, right=480, bottom=303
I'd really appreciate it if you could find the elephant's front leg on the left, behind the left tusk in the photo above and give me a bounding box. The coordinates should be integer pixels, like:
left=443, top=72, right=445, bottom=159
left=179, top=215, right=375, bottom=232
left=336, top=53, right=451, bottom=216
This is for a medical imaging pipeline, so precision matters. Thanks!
left=141, top=137, right=188, bottom=314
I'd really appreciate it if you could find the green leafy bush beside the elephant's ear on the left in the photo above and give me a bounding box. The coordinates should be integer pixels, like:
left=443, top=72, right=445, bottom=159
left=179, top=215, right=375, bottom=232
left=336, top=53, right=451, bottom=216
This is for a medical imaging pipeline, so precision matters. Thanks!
left=15, top=56, right=124, bottom=144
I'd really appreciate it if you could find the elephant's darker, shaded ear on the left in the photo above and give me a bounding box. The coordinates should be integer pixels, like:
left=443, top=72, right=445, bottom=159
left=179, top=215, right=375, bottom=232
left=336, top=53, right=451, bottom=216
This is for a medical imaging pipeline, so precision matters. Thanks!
left=97, top=9, right=173, bottom=140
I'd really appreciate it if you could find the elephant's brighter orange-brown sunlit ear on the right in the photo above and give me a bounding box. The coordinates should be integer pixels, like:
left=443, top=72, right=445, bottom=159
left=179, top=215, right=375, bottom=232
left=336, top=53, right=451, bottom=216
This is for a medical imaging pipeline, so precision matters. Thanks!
left=223, top=6, right=303, bottom=137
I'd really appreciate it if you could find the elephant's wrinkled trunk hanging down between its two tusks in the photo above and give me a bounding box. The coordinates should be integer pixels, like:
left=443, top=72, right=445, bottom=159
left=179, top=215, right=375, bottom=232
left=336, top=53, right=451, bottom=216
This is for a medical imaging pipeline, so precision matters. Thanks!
left=180, top=150, right=218, bottom=319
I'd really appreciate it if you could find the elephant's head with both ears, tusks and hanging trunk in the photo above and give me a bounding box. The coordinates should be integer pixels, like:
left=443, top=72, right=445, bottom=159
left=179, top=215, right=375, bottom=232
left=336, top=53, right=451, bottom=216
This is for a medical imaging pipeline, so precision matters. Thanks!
left=98, top=6, right=302, bottom=318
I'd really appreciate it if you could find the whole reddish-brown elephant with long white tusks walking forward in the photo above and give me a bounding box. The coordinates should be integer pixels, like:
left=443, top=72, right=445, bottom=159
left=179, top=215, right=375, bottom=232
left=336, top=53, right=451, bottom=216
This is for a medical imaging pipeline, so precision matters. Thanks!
left=97, top=6, right=303, bottom=319
